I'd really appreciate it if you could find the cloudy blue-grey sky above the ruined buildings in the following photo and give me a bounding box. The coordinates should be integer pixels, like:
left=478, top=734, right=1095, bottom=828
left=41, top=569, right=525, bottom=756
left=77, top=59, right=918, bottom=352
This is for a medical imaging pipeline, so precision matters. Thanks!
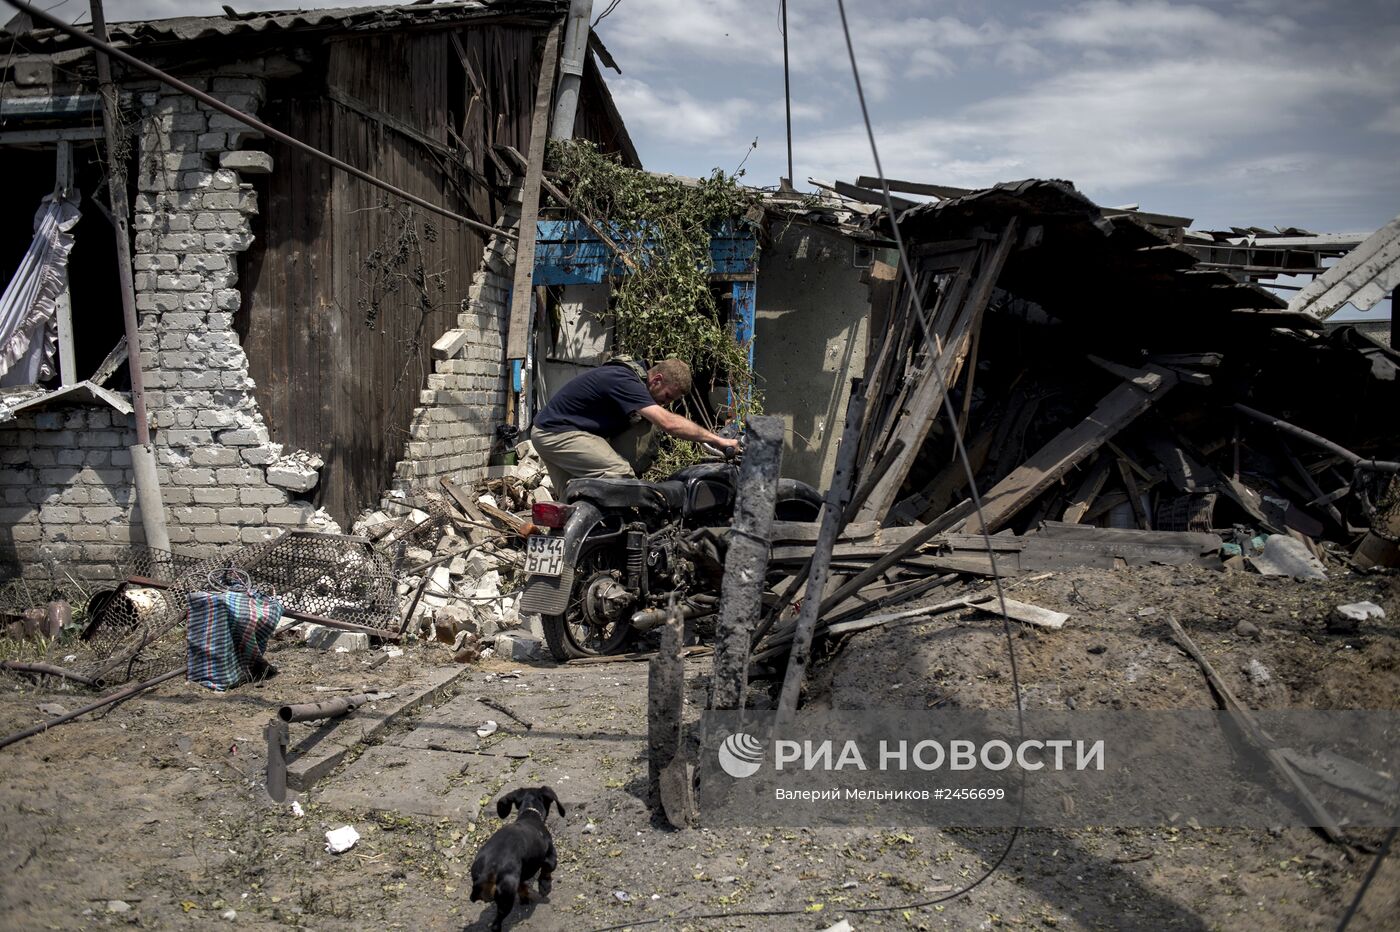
left=79, top=0, right=1400, bottom=312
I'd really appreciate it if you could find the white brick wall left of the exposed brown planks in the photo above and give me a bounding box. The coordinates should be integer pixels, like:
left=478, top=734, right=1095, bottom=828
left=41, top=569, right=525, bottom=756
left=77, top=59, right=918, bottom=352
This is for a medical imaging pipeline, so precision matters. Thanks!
left=0, top=63, right=333, bottom=578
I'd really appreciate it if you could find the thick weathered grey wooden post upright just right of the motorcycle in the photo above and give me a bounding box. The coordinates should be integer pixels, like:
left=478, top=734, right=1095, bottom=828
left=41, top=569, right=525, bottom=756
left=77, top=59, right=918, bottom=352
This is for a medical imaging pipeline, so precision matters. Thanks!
left=710, top=417, right=783, bottom=709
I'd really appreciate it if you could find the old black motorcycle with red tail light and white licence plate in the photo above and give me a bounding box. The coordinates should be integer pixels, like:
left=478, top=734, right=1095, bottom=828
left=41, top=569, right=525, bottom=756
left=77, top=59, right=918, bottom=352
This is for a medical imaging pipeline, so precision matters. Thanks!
left=519, top=462, right=822, bottom=661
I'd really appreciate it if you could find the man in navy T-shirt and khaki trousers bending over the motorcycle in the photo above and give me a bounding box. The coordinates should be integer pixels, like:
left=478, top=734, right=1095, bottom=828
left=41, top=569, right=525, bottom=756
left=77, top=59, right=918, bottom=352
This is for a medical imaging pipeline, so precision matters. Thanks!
left=531, top=357, right=739, bottom=501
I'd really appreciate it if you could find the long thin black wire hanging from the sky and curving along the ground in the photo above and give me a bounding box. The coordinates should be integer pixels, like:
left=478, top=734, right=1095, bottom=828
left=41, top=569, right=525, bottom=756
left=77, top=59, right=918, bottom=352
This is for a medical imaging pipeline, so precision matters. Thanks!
left=579, top=0, right=1030, bottom=932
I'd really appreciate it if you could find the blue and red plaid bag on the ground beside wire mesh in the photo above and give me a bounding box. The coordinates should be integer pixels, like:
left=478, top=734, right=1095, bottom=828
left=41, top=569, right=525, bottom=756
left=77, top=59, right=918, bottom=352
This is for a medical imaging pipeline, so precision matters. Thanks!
left=185, top=591, right=281, bottom=693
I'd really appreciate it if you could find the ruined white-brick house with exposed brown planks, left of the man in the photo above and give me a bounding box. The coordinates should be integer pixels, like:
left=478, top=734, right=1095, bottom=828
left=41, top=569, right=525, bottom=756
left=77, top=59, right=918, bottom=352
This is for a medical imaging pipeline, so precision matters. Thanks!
left=0, top=0, right=636, bottom=577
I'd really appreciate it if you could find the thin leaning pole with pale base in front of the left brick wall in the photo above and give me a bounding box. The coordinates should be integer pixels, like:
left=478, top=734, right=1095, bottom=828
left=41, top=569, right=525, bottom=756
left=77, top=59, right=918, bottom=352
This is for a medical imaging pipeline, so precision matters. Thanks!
left=92, top=0, right=171, bottom=551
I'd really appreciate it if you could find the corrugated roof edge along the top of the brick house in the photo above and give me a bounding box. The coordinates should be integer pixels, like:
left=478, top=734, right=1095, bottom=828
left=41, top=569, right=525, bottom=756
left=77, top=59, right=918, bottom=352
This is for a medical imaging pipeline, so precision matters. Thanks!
left=6, top=0, right=568, bottom=50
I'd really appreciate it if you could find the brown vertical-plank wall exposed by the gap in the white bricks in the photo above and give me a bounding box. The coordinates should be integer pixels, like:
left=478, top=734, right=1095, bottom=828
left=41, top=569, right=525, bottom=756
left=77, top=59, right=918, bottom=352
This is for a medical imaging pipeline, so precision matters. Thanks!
left=242, top=25, right=542, bottom=526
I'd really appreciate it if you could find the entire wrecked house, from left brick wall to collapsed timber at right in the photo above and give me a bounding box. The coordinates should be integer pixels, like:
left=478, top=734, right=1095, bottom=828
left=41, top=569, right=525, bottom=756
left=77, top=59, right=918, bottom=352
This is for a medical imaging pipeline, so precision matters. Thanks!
left=0, top=0, right=1394, bottom=587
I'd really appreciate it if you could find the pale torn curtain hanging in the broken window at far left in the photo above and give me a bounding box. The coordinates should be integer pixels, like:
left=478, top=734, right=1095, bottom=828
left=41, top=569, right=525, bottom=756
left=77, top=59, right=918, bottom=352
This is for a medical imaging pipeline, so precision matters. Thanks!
left=0, top=190, right=81, bottom=385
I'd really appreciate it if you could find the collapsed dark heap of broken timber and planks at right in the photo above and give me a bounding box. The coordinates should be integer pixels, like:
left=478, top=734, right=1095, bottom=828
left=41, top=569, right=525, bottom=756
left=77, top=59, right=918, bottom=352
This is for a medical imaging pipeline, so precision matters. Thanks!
left=755, top=182, right=1400, bottom=666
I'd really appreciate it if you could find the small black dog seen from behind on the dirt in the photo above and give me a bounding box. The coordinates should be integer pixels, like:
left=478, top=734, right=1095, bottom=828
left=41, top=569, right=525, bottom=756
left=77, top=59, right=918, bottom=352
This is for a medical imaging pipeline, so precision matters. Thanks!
left=472, top=786, right=564, bottom=932
